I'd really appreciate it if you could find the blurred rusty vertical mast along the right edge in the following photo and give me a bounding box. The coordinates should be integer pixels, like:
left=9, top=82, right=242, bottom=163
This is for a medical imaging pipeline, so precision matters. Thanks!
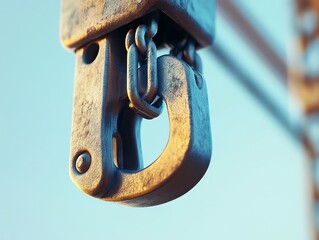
left=296, top=0, right=319, bottom=240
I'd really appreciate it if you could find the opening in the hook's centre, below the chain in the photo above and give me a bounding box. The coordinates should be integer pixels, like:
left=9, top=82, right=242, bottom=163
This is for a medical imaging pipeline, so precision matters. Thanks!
left=112, top=104, right=169, bottom=171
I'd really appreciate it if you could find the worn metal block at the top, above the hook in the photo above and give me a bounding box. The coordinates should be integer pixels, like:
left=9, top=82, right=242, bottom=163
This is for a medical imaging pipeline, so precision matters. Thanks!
left=61, top=0, right=215, bottom=49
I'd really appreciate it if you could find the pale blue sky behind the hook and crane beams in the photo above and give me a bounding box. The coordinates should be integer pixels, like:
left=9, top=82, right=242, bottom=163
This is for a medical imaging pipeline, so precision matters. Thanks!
left=0, top=0, right=309, bottom=240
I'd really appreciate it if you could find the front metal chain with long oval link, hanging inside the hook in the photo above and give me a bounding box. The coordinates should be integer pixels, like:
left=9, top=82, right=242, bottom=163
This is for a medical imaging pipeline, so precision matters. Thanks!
left=125, top=19, right=163, bottom=119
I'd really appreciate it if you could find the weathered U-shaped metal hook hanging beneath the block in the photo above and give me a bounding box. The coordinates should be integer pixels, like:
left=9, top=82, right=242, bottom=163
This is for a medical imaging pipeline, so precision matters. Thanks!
left=70, top=31, right=212, bottom=206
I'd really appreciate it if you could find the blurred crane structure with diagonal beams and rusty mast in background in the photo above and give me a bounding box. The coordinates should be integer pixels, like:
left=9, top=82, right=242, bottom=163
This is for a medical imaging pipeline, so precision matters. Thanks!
left=212, top=0, right=319, bottom=240
